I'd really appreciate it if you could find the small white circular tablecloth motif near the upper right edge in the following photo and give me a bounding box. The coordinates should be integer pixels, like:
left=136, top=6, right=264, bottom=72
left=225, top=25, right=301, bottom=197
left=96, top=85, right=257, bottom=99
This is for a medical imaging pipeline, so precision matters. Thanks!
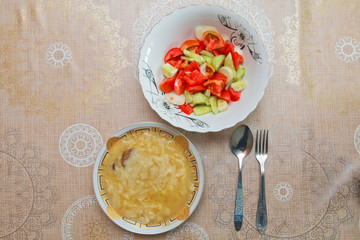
left=335, top=37, right=360, bottom=63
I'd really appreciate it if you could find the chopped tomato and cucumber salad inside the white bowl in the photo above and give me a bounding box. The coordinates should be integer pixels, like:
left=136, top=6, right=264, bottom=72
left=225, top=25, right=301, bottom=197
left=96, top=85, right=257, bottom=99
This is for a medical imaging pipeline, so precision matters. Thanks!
left=159, top=26, right=246, bottom=115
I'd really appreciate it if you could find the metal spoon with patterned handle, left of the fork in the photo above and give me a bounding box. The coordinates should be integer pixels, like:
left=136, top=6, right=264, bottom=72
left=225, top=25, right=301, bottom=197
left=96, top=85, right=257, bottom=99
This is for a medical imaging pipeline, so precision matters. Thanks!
left=230, top=125, right=253, bottom=231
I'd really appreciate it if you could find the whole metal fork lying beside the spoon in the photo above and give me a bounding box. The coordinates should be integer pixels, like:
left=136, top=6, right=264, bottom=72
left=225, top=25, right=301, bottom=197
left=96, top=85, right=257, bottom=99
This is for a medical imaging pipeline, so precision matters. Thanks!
left=255, top=130, right=269, bottom=234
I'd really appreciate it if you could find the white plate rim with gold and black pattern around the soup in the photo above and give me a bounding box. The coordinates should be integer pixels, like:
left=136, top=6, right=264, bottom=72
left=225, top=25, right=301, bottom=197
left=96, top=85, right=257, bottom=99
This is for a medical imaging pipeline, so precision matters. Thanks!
left=93, top=123, right=204, bottom=234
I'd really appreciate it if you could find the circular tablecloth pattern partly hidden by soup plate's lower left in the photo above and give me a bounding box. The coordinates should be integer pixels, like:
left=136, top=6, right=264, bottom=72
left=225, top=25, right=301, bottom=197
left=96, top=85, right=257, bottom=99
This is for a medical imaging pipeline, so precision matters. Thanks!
left=61, top=195, right=134, bottom=240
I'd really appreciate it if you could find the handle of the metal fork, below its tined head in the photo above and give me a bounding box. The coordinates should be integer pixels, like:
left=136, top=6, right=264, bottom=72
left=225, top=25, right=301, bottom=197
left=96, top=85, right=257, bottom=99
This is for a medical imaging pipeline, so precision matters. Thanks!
left=256, top=164, right=268, bottom=234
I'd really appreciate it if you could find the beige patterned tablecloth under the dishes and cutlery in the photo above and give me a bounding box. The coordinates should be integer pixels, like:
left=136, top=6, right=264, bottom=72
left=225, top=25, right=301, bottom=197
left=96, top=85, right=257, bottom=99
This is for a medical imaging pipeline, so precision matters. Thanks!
left=0, top=0, right=360, bottom=239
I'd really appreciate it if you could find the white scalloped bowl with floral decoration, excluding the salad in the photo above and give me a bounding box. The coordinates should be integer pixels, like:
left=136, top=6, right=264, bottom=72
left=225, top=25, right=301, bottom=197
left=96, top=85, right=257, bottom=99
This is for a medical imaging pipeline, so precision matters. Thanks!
left=138, top=5, right=268, bottom=132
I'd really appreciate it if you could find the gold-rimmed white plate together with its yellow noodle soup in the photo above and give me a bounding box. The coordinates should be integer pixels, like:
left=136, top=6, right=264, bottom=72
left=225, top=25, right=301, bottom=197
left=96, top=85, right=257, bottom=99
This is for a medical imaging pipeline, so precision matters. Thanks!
left=93, top=123, right=204, bottom=234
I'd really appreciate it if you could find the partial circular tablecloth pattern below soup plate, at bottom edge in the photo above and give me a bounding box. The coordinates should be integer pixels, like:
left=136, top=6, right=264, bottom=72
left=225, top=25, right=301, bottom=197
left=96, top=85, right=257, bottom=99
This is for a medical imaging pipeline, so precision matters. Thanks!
left=166, top=222, right=209, bottom=240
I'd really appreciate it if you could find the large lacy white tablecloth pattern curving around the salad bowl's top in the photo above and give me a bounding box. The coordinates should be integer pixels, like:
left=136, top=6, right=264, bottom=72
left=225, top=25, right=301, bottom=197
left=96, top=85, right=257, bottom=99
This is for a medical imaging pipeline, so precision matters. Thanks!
left=130, top=0, right=276, bottom=78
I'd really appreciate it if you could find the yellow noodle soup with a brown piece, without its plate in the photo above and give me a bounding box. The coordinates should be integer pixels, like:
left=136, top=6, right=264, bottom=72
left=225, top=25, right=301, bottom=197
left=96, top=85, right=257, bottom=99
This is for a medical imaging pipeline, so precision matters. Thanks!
left=104, top=132, right=193, bottom=224
